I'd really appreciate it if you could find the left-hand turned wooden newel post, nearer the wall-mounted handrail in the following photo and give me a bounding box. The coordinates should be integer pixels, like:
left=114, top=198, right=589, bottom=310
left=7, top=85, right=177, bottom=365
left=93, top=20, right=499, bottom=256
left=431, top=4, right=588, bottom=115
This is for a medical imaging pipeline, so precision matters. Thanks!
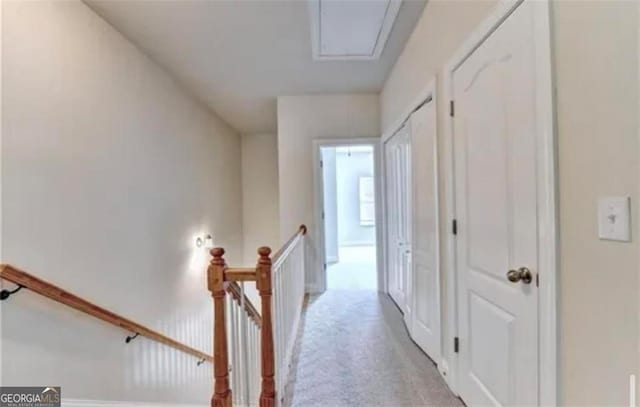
left=207, top=247, right=231, bottom=407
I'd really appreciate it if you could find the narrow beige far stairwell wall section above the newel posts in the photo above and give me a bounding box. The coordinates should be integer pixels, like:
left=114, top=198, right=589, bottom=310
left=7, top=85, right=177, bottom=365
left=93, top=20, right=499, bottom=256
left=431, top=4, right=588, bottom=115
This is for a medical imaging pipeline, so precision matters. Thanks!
left=242, top=134, right=280, bottom=266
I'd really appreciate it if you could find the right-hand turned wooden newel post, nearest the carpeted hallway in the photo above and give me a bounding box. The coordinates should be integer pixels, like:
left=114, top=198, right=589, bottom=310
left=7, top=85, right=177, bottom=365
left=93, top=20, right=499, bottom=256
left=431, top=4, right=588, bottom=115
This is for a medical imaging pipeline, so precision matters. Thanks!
left=256, top=247, right=276, bottom=407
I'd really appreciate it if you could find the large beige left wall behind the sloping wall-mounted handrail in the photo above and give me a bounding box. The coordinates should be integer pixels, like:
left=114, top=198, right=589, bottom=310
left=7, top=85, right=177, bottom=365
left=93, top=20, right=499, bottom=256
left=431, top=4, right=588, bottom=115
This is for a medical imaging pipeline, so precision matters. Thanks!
left=2, top=1, right=242, bottom=405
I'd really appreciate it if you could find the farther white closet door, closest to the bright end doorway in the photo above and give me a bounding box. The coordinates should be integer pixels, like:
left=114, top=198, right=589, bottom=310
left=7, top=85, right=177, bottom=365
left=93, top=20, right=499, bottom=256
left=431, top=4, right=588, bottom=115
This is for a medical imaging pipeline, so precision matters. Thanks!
left=385, top=128, right=411, bottom=312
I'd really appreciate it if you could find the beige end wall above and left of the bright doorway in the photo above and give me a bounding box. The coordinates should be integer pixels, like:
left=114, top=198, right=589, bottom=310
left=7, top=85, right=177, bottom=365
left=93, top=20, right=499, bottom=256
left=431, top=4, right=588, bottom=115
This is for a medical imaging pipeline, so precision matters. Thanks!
left=278, top=94, right=380, bottom=290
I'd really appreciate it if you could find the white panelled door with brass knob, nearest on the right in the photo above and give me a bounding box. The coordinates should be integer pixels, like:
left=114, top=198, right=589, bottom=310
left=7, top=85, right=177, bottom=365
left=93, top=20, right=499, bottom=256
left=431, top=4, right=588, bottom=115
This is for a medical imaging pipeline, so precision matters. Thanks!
left=452, top=1, right=538, bottom=406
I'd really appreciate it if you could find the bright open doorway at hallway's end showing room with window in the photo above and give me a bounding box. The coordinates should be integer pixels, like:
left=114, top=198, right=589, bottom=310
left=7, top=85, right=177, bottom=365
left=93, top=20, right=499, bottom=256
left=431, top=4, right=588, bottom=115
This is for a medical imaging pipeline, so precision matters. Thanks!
left=320, top=144, right=378, bottom=290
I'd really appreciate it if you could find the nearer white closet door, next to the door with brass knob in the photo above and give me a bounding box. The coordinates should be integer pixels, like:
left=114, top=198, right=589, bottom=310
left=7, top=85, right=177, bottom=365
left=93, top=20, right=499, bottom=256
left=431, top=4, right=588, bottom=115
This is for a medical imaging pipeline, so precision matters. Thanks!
left=406, top=101, right=441, bottom=361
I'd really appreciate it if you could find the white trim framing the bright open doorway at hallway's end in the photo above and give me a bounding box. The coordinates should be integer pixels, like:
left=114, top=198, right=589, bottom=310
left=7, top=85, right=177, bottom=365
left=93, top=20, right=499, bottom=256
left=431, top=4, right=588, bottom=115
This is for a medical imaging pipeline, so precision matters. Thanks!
left=306, top=137, right=386, bottom=293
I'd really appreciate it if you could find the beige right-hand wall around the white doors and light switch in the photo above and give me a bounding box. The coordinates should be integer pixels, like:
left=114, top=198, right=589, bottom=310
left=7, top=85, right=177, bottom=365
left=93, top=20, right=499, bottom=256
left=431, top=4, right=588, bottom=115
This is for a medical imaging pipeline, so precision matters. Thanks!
left=380, top=0, right=640, bottom=405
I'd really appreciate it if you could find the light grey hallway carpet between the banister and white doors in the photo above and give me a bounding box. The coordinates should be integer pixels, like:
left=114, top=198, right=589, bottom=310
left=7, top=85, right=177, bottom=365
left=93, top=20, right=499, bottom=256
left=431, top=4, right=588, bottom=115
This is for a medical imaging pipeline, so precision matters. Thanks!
left=284, top=290, right=463, bottom=407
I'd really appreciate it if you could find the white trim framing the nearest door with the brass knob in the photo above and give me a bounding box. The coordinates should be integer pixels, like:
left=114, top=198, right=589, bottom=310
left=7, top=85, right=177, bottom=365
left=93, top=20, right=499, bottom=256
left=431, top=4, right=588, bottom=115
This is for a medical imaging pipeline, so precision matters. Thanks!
left=443, top=0, right=560, bottom=406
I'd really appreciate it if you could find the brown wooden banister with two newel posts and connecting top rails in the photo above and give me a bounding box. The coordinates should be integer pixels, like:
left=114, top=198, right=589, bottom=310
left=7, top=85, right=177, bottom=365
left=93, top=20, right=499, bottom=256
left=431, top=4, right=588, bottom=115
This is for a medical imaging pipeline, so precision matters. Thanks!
left=207, top=225, right=307, bottom=407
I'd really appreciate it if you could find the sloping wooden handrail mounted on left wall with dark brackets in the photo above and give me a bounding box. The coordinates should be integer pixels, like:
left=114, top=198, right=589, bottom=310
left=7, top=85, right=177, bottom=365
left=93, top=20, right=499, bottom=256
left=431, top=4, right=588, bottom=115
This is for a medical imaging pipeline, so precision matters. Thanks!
left=0, top=264, right=213, bottom=362
